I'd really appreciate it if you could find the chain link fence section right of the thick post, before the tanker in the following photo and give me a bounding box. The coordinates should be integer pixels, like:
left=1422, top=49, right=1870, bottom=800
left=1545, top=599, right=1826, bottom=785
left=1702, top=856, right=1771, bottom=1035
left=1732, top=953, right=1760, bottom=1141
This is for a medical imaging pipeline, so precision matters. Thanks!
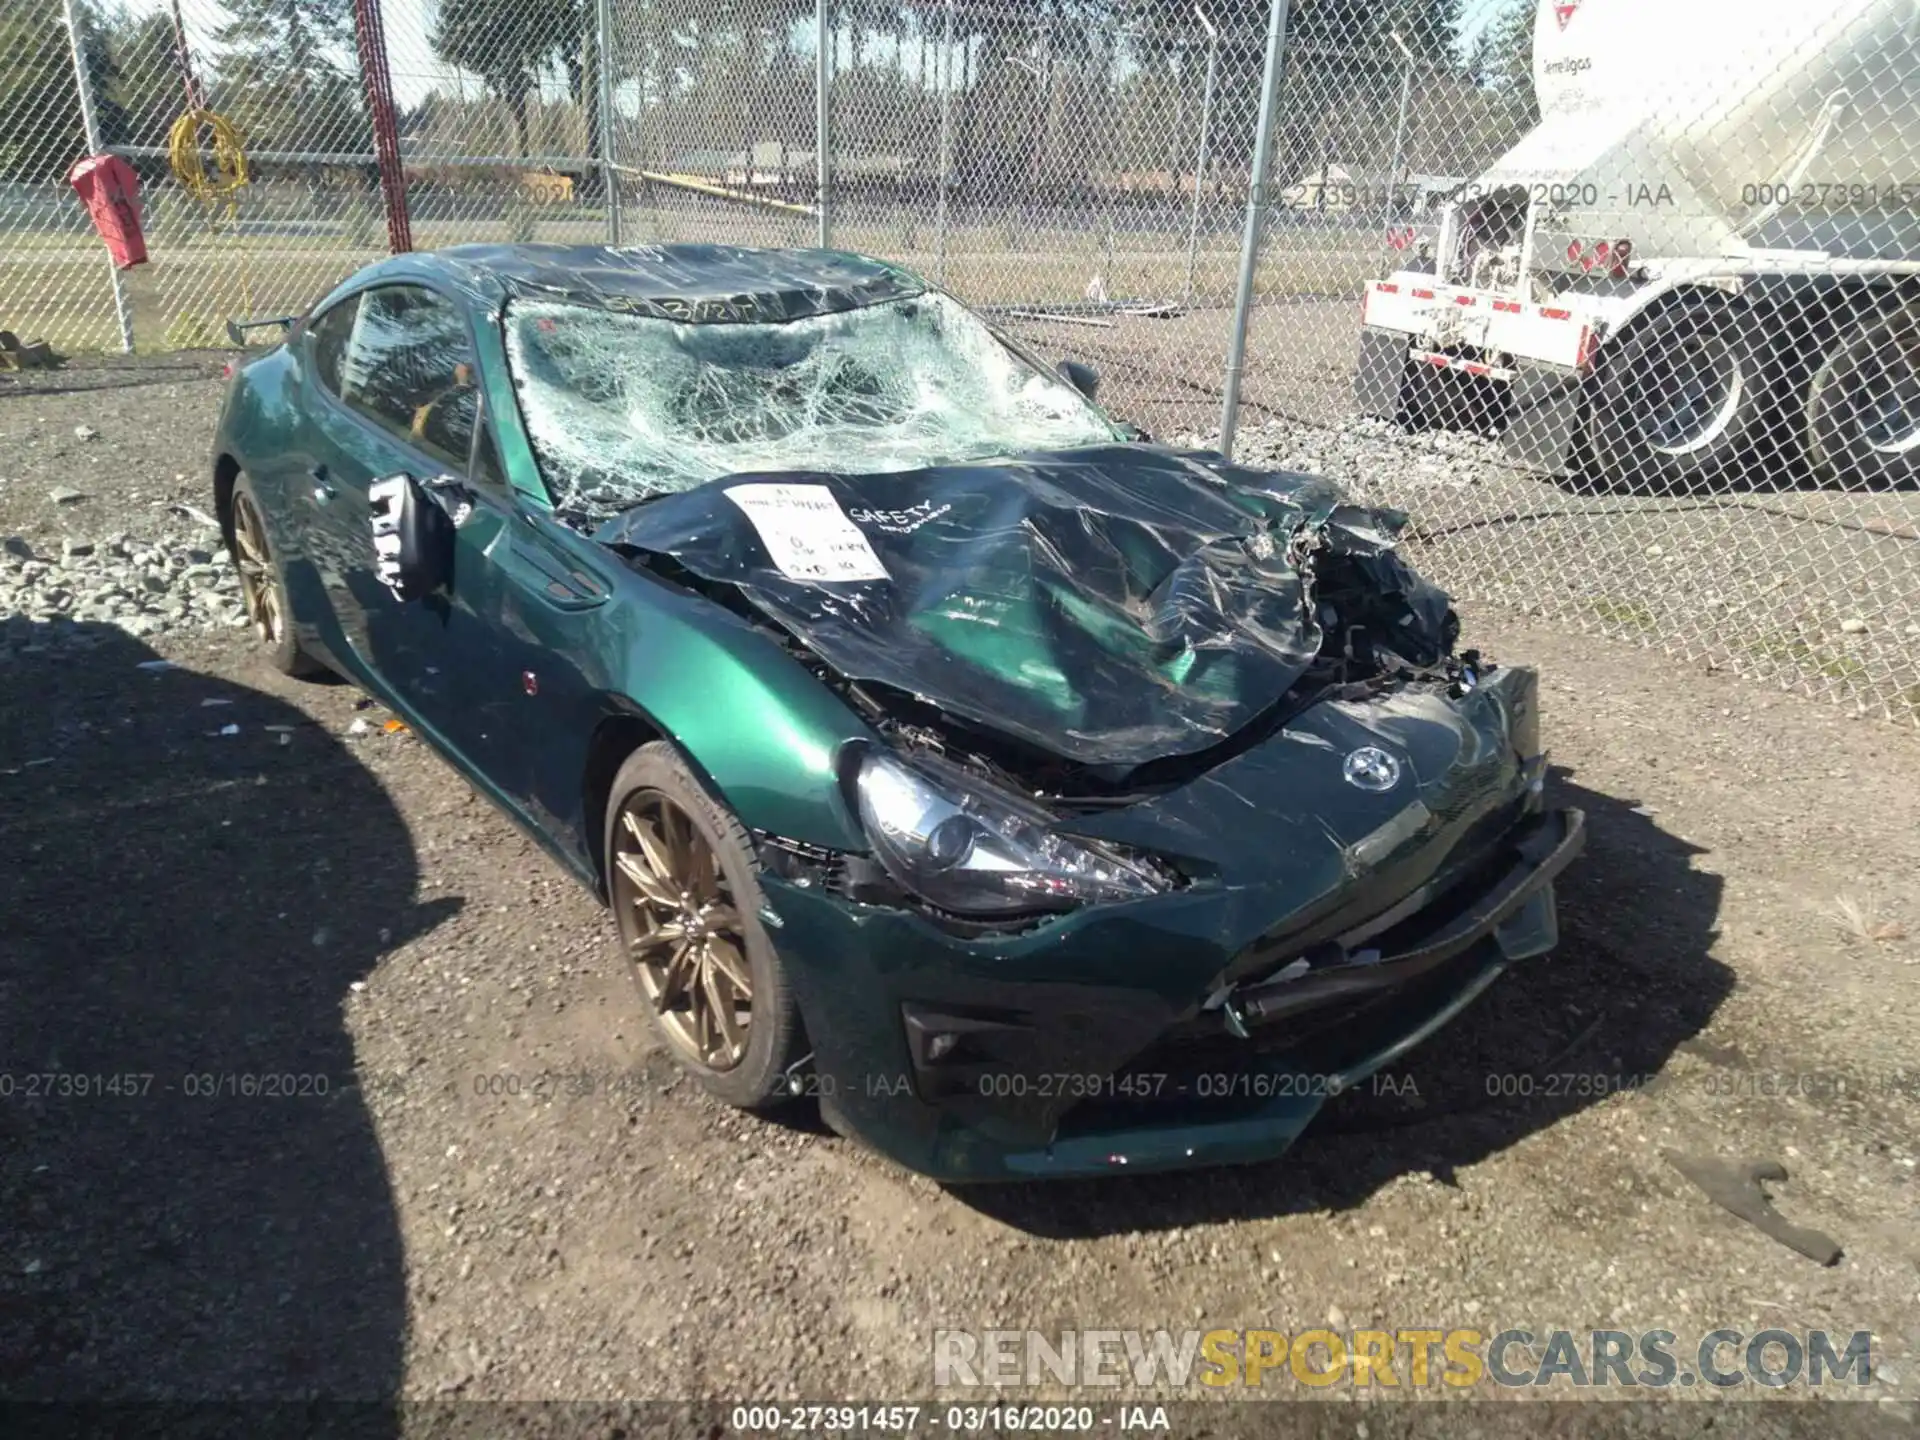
left=1240, top=0, right=1920, bottom=720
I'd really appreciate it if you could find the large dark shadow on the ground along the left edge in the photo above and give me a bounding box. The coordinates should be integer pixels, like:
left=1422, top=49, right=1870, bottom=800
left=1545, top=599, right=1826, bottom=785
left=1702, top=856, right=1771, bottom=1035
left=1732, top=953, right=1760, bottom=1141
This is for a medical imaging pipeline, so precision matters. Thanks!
left=0, top=626, right=457, bottom=1428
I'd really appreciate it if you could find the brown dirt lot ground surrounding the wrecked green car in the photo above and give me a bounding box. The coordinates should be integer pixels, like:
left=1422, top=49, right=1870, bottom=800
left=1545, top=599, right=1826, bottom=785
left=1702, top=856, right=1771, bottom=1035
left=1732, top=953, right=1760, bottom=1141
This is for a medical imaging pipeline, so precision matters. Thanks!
left=0, top=357, right=1920, bottom=1436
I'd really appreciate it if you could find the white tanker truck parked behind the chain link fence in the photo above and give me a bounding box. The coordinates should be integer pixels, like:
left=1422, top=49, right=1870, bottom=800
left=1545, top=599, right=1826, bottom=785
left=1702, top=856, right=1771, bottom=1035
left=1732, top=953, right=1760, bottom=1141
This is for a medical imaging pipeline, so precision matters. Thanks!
left=1356, top=0, right=1920, bottom=488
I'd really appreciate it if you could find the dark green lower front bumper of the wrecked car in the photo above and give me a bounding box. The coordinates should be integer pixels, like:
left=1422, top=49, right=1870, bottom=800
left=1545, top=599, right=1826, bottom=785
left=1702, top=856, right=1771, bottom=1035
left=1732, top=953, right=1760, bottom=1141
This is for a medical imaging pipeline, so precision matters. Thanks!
left=787, top=812, right=1584, bottom=1183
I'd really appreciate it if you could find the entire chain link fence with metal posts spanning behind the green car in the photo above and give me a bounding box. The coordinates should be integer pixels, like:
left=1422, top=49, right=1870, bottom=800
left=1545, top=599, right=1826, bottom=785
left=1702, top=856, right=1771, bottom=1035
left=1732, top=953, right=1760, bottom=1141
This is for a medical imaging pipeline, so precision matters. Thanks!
left=0, top=0, right=1920, bottom=718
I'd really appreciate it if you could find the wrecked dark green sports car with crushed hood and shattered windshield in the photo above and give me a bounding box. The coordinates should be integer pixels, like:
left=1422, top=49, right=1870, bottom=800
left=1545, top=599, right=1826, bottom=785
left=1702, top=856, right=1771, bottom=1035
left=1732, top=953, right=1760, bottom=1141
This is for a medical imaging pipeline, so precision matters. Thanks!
left=213, top=246, right=1582, bottom=1181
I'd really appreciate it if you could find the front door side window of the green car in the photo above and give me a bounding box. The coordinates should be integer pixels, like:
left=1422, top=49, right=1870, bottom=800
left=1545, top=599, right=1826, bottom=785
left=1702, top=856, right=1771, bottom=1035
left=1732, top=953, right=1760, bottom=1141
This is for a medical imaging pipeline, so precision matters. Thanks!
left=340, top=284, right=480, bottom=470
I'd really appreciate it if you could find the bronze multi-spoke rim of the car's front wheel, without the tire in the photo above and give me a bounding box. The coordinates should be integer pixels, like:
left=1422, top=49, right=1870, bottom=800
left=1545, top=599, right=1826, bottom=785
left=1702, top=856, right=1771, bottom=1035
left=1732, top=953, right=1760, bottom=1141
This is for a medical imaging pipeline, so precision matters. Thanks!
left=612, top=789, right=753, bottom=1071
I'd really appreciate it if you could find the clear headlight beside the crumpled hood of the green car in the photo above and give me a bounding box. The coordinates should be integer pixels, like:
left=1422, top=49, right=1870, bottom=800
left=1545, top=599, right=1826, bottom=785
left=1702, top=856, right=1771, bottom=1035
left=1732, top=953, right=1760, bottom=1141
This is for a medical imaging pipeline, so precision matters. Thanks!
left=856, top=751, right=1169, bottom=916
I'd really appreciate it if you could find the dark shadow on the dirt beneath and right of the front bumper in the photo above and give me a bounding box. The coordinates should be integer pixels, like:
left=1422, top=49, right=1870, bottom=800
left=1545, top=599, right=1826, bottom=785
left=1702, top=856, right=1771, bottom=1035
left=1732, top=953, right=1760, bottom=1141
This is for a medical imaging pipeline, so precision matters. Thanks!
left=952, top=770, right=1734, bottom=1238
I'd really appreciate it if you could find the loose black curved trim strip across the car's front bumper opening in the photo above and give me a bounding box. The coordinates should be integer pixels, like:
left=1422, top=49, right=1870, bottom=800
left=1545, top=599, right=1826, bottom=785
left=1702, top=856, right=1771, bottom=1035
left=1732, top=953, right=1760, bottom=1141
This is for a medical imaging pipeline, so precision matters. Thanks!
left=1223, top=810, right=1586, bottom=1037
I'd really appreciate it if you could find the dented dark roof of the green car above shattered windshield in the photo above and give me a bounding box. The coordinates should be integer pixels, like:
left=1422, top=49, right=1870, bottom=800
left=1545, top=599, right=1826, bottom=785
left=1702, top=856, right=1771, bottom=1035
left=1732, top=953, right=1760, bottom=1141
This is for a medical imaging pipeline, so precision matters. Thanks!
left=372, top=244, right=927, bottom=324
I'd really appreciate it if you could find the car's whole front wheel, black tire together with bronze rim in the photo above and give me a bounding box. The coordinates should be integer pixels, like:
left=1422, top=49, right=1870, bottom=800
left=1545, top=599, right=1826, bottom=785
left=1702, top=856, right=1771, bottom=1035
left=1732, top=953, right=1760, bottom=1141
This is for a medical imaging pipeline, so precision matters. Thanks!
left=601, top=741, right=804, bottom=1110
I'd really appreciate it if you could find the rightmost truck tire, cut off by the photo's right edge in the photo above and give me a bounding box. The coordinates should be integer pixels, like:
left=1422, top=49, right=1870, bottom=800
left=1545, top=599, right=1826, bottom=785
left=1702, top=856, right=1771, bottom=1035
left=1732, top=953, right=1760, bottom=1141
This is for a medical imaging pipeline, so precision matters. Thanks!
left=1807, top=303, right=1920, bottom=488
